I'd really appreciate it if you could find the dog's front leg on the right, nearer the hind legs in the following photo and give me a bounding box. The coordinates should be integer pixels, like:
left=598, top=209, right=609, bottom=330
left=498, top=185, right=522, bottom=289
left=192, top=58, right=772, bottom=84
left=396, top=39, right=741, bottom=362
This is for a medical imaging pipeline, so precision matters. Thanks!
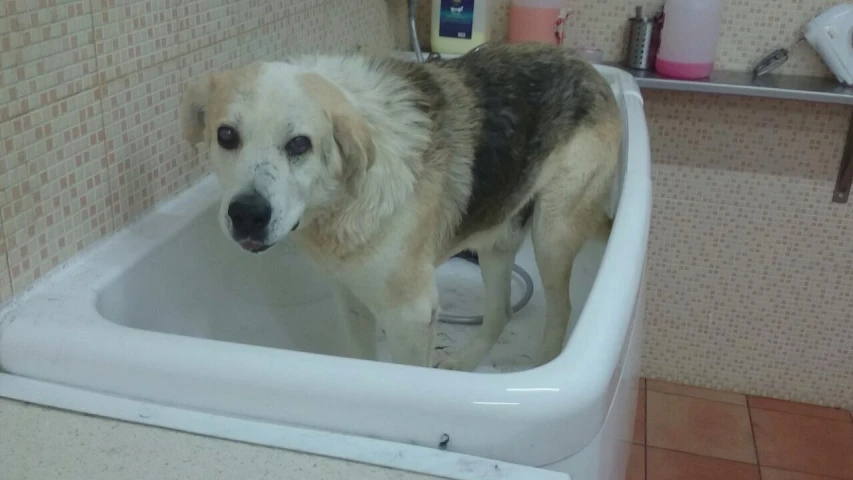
left=374, top=284, right=438, bottom=367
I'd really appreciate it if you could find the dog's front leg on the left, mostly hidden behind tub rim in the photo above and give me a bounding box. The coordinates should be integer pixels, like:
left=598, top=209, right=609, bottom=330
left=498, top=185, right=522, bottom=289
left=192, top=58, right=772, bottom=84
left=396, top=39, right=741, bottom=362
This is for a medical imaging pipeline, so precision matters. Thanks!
left=334, top=284, right=376, bottom=360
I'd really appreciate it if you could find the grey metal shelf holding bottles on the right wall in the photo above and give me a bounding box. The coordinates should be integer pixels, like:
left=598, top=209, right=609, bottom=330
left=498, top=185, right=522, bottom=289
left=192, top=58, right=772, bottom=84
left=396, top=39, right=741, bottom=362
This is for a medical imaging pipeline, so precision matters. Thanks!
left=608, top=63, right=853, bottom=105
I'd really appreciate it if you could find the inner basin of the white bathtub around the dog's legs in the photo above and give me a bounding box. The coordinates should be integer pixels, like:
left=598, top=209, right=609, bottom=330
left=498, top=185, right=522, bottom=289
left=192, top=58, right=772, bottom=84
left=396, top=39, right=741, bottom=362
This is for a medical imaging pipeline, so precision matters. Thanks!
left=96, top=198, right=606, bottom=373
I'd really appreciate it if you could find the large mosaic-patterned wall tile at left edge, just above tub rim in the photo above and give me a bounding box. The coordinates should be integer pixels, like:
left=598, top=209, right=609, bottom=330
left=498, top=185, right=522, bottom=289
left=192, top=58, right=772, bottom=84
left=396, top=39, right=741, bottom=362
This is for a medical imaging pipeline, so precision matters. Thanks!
left=0, top=89, right=113, bottom=293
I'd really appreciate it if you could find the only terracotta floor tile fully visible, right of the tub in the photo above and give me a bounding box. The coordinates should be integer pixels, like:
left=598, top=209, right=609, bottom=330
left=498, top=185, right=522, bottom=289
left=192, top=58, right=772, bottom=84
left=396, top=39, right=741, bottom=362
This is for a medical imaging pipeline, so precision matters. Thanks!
left=646, top=390, right=756, bottom=464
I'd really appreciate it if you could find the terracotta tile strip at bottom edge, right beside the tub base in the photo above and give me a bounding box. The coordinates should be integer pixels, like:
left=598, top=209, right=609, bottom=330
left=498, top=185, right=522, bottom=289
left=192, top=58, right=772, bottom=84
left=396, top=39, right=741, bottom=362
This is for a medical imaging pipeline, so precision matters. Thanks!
left=646, top=447, right=761, bottom=480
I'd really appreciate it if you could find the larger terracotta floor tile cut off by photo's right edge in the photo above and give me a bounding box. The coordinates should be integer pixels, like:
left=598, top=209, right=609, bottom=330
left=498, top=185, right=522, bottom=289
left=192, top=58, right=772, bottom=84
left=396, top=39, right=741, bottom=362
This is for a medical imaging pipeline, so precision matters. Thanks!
left=752, top=408, right=853, bottom=480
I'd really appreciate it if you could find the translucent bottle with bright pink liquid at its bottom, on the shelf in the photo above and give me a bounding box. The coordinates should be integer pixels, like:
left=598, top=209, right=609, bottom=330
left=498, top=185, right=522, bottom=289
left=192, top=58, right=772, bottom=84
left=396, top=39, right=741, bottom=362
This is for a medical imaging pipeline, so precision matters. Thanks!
left=655, top=0, right=723, bottom=79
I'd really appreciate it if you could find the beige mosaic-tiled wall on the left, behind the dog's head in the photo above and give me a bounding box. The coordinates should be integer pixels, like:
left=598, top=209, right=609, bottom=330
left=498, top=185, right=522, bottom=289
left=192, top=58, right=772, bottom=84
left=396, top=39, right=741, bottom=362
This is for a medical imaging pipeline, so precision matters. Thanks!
left=0, top=0, right=406, bottom=300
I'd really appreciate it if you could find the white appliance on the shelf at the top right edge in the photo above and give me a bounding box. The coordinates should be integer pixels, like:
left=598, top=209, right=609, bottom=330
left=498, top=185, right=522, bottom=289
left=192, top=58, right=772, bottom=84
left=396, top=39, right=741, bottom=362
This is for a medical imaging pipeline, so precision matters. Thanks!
left=805, top=3, right=853, bottom=85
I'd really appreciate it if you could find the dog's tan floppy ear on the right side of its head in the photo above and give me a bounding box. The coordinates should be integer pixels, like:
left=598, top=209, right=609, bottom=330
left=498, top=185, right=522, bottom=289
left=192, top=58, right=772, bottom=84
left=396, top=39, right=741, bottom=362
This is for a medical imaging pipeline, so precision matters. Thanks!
left=301, top=73, right=376, bottom=195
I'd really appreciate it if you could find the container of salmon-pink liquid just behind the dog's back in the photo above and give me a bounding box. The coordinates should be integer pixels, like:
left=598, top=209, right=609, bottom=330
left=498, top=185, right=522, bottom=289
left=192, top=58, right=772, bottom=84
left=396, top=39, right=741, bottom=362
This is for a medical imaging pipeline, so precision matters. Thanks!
left=508, top=0, right=568, bottom=45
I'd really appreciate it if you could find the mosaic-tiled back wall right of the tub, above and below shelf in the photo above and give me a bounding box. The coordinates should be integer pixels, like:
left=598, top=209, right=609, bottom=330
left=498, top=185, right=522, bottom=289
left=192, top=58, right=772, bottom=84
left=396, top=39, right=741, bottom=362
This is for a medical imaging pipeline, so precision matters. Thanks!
left=419, top=0, right=853, bottom=408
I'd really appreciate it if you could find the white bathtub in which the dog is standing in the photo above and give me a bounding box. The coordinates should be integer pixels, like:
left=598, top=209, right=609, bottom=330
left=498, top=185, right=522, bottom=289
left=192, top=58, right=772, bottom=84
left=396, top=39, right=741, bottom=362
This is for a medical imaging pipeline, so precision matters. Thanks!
left=0, top=66, right=651, bottom=480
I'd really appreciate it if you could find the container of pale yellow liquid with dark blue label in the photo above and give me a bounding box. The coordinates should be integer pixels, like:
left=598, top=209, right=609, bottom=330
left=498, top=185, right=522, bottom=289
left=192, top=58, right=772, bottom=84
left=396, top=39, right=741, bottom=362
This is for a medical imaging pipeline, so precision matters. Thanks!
left=430, top=0, right=490, bottom=55
